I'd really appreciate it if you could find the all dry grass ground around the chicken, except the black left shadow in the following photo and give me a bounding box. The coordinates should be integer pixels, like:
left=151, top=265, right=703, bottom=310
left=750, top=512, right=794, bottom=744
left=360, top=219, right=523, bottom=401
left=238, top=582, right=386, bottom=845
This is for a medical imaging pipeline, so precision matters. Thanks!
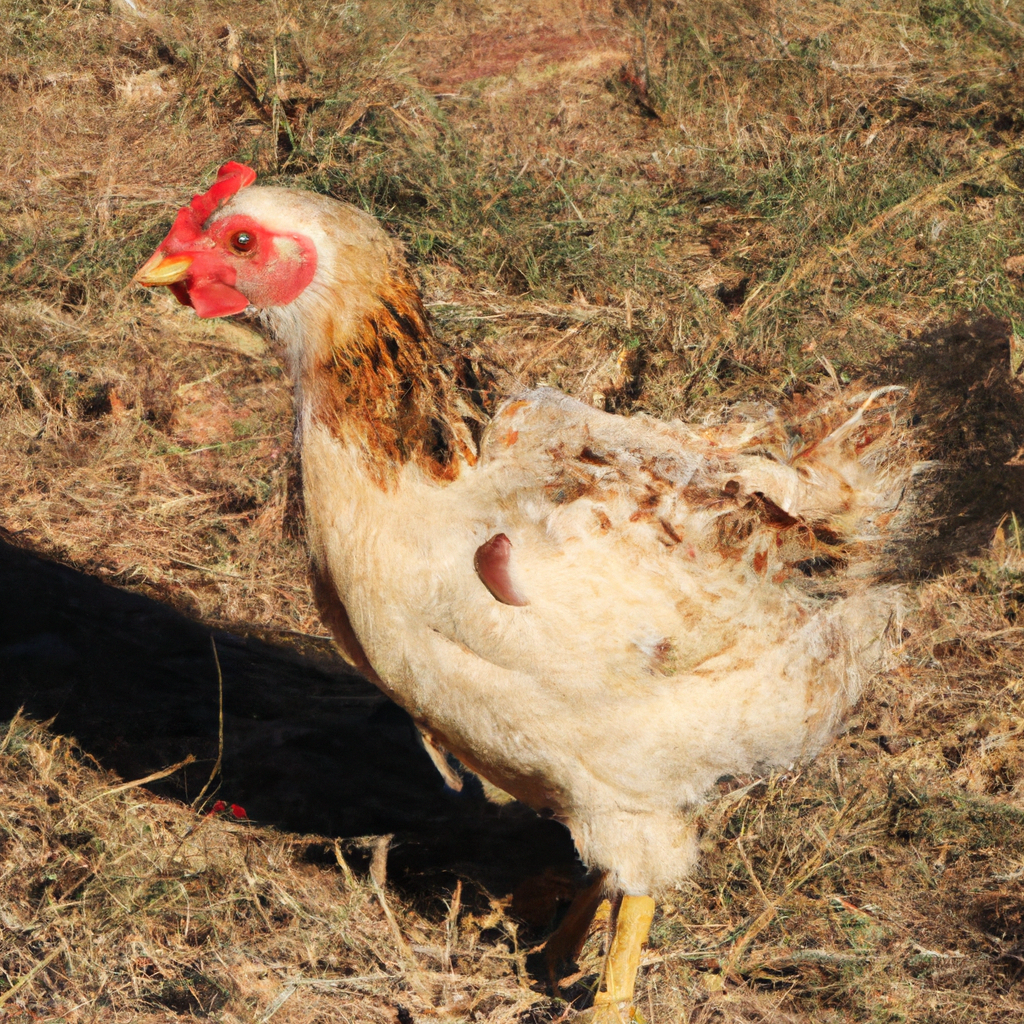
left=0, top=0, right=1024, bottom=1024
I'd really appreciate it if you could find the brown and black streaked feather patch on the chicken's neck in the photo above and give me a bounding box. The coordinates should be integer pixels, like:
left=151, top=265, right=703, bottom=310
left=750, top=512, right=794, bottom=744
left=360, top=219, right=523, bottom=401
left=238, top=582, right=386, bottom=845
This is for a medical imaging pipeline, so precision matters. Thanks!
left=313, top=271, right=484, bottom=486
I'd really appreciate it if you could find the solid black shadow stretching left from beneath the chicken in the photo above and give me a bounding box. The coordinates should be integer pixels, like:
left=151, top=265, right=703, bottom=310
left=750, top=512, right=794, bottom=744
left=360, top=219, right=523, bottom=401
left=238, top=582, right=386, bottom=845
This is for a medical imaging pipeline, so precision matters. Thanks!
left=0, top=536, right=583, bottom=903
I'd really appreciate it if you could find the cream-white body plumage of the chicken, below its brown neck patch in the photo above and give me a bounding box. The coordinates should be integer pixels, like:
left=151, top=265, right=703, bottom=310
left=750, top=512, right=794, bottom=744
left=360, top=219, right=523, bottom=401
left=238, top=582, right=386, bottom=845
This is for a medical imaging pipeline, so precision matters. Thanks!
left=302, top=380, right=905, bottom=893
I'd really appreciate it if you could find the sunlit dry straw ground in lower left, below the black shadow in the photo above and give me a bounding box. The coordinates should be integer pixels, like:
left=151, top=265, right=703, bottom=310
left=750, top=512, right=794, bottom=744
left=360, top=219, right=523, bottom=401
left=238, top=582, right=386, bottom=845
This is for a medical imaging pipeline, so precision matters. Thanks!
left=0, top=718, right=539, bottom=1024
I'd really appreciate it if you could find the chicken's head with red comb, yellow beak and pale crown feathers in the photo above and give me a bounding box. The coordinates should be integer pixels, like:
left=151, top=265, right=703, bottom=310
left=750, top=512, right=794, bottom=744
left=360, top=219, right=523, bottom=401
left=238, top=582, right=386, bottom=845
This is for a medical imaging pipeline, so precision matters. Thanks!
left=135, top=162, right=400, bottom=322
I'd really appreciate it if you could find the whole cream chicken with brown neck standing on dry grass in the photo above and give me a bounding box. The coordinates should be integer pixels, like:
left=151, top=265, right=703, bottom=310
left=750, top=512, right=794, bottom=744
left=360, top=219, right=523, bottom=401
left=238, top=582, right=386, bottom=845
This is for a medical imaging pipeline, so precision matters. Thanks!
left=136, top=163, right=913, bottom=1021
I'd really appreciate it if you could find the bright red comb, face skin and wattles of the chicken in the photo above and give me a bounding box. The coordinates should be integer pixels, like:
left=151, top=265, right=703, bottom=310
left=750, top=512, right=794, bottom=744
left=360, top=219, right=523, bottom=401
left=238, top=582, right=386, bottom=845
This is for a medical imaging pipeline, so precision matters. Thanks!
left=146, top=162, right=316, bottom=317
